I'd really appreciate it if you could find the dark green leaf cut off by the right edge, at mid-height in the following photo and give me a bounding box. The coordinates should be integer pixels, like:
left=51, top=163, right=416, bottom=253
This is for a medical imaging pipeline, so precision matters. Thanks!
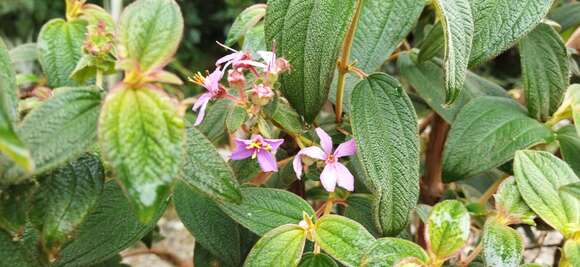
left=556, top=125, right=580, bottom=176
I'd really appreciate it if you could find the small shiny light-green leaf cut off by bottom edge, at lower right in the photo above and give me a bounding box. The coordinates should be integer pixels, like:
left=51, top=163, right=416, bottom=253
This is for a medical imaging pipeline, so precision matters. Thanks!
left=481, top=219, right=524, bottom=267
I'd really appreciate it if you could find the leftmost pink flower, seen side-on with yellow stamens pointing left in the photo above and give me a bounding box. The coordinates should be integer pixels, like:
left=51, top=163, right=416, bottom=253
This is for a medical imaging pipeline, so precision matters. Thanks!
left=190, top=68, right=226, bottom=126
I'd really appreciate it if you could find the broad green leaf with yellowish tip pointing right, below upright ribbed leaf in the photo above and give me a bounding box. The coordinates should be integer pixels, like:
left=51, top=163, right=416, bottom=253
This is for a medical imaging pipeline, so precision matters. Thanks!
left=443, top=96, right=552, bottom=182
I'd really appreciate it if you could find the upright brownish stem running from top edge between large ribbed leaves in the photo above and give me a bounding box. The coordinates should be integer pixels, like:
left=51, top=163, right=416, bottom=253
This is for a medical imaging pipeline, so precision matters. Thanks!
left=336, top=0, right=363, bottom=123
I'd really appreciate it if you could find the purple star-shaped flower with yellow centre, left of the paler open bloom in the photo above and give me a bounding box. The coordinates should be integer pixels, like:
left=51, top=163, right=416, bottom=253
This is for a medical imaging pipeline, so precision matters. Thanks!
left=231, top=135, right=284, bottom=172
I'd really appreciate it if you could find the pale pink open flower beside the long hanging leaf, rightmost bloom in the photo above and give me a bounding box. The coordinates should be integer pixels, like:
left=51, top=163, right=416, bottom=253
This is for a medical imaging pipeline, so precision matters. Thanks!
left=293, top=128, right=356, bottom=192
